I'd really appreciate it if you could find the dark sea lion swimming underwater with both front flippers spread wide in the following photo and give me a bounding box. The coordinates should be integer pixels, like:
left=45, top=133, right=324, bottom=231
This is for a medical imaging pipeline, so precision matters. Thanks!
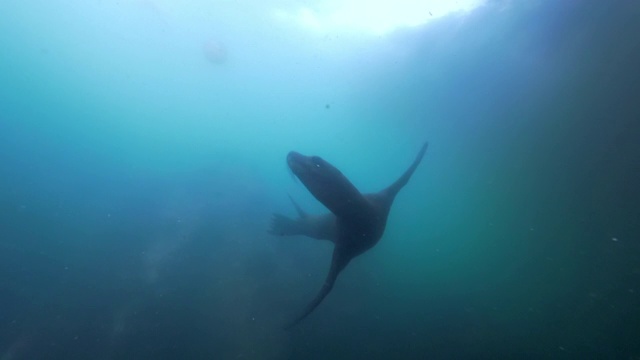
left=269, top=143, right=428, bottom=329
